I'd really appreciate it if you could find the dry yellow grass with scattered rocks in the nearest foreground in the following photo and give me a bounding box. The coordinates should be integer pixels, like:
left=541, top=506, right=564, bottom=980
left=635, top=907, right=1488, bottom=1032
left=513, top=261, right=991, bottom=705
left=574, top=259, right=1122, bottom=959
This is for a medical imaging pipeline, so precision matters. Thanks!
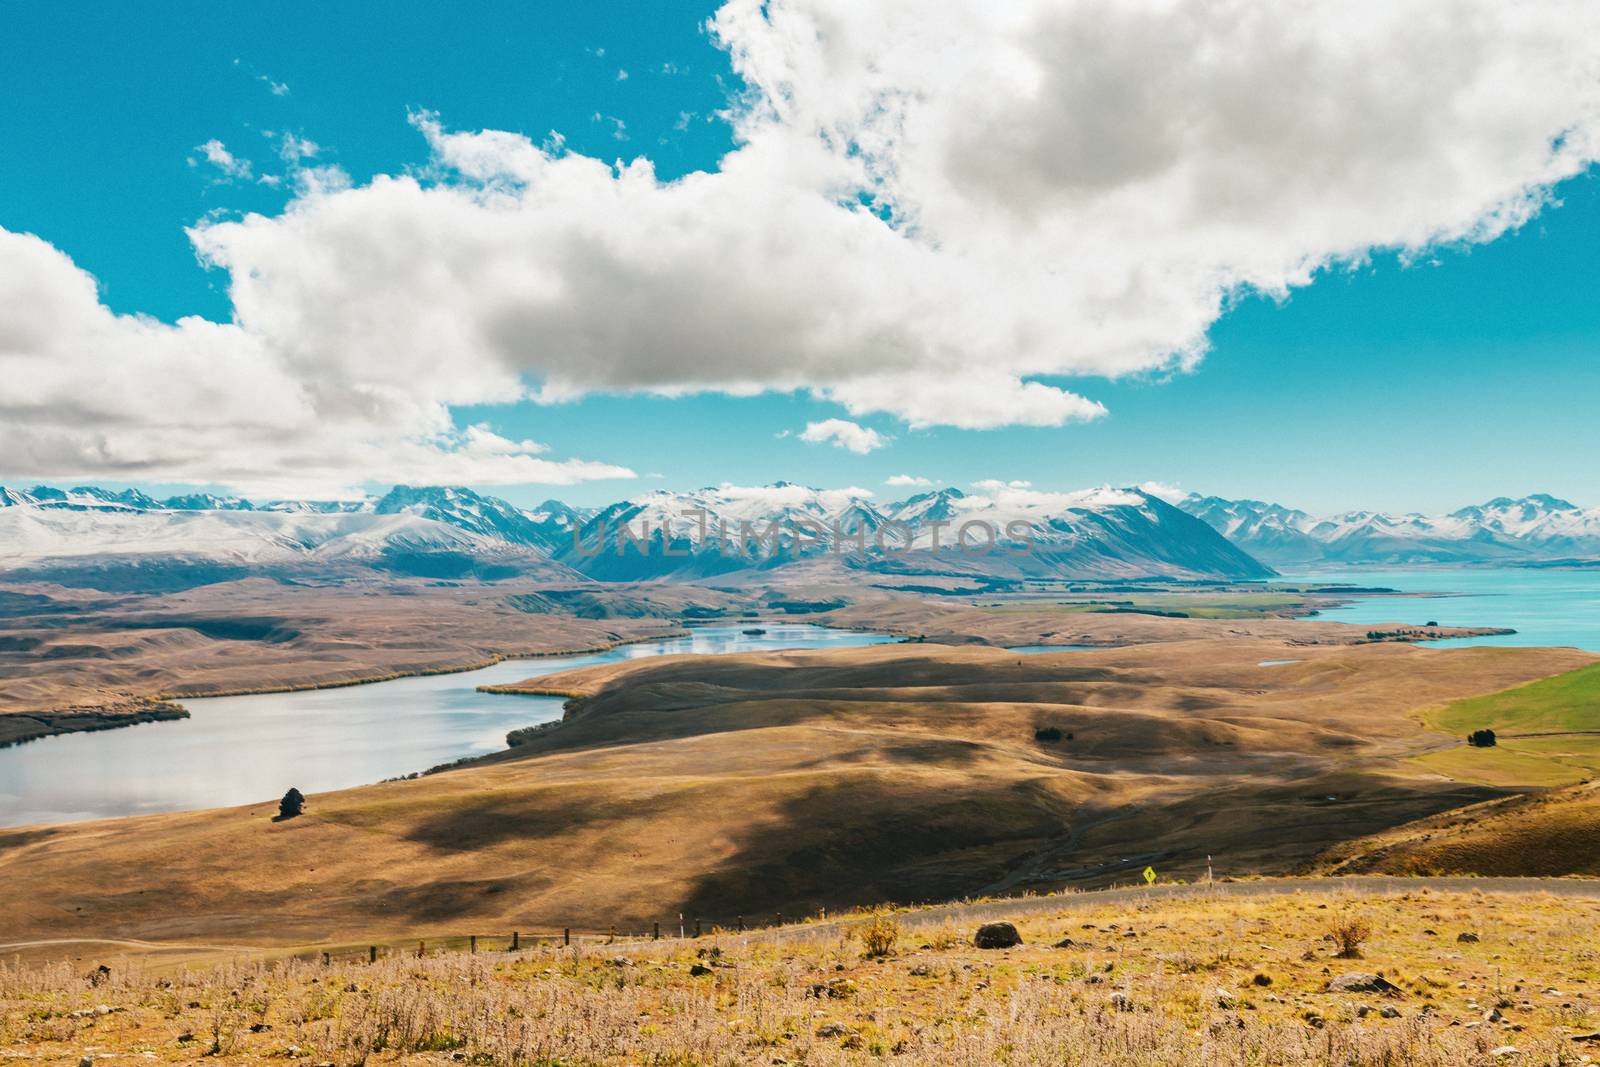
left=9, top=889, right=1600, bottom=1067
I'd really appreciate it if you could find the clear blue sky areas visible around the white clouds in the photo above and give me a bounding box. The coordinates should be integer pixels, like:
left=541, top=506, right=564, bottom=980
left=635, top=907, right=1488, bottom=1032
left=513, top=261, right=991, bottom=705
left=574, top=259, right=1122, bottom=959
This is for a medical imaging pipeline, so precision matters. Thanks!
left=0, top=2, right=1600, bottom=510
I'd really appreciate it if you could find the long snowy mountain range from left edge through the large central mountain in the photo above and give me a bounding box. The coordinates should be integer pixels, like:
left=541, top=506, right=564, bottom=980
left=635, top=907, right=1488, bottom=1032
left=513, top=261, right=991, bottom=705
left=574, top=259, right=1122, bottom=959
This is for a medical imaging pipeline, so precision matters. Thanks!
left=0, top=483, right=1270, bottom=581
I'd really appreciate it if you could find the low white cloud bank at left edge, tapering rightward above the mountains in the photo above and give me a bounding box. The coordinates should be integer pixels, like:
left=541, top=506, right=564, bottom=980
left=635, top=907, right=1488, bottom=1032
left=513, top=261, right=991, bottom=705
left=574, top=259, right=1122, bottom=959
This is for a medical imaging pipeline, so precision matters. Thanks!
left=0, top=229, right=632, bottom=496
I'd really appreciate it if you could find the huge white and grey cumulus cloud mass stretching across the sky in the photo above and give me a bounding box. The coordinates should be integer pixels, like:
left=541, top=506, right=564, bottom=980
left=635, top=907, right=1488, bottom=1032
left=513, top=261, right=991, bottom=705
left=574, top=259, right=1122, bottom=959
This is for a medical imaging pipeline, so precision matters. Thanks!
left=9, top=0, right=1600, bottom=489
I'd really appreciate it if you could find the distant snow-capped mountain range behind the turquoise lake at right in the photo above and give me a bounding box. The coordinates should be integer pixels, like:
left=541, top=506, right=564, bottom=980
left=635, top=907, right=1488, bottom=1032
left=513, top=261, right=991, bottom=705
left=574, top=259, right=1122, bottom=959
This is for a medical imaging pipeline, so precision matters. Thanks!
left=1178, top=493, right=1600, bottom=566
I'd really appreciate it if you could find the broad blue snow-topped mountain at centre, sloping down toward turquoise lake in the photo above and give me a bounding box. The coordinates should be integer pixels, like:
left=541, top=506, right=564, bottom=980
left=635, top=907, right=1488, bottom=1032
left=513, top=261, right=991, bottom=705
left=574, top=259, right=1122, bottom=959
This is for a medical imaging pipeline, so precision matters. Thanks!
left=558, top=482, right=1270, bottom=579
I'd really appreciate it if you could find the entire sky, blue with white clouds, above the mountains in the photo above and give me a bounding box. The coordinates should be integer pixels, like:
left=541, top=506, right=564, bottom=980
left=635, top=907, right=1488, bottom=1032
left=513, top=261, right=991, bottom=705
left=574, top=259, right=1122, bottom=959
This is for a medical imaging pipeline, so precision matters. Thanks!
left=0, top=0, right=1600, bottom=512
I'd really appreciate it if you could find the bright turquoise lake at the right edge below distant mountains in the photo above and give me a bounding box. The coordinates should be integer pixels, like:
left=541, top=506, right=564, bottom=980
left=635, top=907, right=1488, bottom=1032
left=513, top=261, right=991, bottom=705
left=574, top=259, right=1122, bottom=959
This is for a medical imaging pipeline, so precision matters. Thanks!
left=1285, top=568, right=1600, bottom=651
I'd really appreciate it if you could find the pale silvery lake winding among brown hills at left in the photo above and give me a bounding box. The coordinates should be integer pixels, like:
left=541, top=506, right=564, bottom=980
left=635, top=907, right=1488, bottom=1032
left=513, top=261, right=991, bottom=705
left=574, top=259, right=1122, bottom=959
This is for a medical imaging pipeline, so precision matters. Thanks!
left=0, top=622, right=896, bottom=825
